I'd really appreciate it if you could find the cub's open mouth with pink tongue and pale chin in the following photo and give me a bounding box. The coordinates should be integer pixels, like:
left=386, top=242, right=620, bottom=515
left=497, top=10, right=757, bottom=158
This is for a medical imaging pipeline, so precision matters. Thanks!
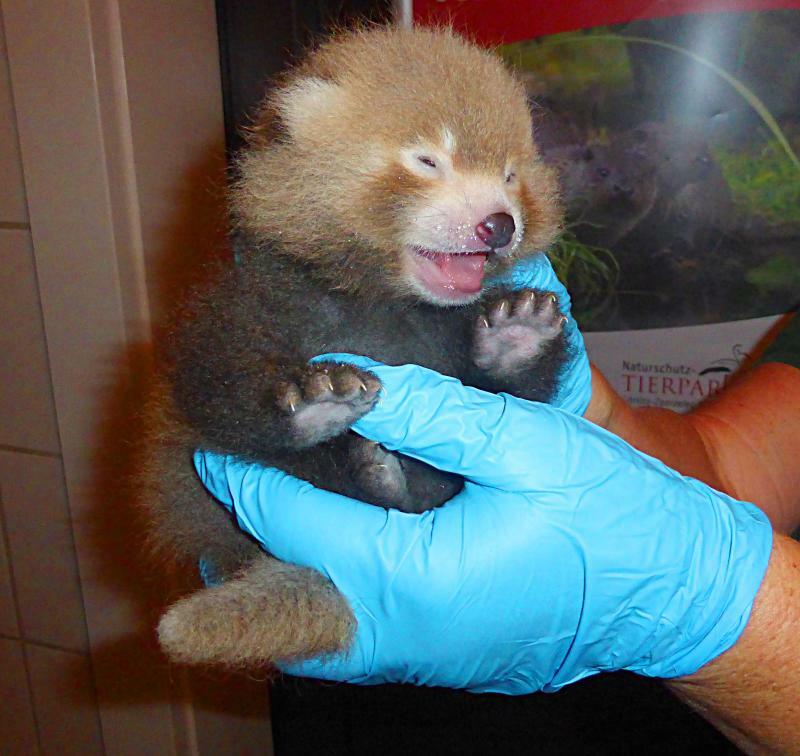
left=412, top=247, right=491, bottom=302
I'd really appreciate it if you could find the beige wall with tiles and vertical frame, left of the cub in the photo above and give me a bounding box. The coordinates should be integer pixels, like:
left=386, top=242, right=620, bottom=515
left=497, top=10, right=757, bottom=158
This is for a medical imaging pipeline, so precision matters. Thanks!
left=0, top=0, right=271, bottom=756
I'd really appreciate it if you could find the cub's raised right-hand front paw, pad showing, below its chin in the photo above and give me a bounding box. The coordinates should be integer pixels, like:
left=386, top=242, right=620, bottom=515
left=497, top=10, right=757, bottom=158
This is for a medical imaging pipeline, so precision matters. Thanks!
left=472, top=289, right=567, bottom=375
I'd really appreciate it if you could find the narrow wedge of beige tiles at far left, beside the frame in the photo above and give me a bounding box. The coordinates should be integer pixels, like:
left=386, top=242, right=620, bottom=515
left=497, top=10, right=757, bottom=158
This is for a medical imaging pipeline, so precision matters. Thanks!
left=0, top=4, right=103, bottom=756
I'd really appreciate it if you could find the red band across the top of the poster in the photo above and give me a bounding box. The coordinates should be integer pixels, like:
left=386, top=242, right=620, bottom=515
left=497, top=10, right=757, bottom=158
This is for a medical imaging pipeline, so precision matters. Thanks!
left=413, top=0, right=800, bottom=45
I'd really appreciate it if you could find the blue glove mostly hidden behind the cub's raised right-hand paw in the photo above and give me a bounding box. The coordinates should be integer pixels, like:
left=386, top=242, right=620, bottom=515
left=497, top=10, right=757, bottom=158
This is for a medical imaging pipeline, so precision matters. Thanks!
left=489, top=253, right=592, bottom=415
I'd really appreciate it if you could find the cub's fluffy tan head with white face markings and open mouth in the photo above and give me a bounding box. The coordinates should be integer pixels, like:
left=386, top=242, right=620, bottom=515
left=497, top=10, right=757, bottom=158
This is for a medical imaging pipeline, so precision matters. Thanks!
left=233, top=28, right=560, bottom=305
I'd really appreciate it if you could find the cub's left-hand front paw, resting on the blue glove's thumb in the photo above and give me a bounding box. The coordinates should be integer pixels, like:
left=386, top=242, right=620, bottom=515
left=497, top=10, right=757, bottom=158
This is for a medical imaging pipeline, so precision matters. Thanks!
left=276, top=362, right=381, bottom=447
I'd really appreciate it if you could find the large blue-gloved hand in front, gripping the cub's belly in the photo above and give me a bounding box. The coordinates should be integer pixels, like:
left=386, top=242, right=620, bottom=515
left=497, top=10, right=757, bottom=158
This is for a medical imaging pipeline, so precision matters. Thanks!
left=195, top=358, right=772, bottom=693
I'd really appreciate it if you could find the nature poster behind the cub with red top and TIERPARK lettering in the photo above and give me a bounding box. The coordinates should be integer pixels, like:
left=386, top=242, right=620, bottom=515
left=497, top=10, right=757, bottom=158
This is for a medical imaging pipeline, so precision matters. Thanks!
left=413, top=0, right=800, bottom=410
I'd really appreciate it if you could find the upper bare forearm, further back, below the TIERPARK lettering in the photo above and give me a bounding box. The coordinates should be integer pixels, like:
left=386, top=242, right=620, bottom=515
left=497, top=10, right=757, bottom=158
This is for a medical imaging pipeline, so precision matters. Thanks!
left=585, top=362, right=800, bottom=533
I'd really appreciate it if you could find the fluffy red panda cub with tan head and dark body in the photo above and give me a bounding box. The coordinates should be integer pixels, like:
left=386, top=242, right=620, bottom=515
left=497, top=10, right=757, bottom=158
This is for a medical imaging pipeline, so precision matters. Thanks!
left=143, top=27, right=567, bottom=667
